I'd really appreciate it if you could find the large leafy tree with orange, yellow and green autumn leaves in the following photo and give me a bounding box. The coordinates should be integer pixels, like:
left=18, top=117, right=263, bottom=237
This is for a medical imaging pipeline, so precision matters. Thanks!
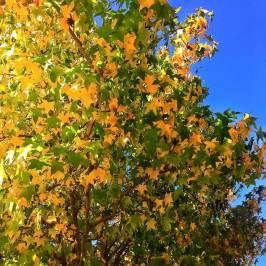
left=0, top=0, right=266, bottom=265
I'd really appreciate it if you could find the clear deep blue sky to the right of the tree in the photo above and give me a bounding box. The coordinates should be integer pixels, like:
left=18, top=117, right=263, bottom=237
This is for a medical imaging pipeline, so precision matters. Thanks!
left=169, top=0, right=266, bottom=266
